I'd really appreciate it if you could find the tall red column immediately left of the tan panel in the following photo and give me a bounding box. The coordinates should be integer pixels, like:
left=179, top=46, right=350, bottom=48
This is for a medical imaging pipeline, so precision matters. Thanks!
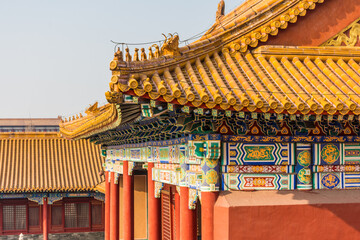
left=123, top=161, right=134, bottom=240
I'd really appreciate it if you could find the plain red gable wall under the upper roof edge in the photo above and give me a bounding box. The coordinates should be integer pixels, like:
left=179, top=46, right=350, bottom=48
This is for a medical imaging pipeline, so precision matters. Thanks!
left=263, top=0, right=360, bottom=46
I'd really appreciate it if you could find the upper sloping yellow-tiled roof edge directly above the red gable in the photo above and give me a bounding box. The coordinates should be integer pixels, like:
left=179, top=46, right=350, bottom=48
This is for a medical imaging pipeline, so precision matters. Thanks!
left=200, top=0, right=310, bottom=43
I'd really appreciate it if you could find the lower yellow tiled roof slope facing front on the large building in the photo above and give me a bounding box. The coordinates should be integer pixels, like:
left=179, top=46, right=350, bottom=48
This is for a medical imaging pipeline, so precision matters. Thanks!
left=114, top=46, right=360, bottom=114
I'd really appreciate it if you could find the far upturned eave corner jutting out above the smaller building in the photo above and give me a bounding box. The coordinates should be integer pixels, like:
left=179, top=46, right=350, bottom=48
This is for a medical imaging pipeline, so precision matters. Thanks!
left=60, top=103, right=140, bottom=139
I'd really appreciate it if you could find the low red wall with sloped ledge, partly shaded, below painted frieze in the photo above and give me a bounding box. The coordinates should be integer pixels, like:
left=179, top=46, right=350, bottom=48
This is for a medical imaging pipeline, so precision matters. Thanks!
left=215, top=190, right=360, bottom=240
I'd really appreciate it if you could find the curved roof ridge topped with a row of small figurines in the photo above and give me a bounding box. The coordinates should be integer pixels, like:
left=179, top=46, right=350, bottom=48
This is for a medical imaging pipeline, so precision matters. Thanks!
left=110, top=0, right=324, bottom=75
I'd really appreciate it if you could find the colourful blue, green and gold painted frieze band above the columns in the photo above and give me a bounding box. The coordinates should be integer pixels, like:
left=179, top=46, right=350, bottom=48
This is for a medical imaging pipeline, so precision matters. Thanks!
left=104, top=134, right=360, bottom=193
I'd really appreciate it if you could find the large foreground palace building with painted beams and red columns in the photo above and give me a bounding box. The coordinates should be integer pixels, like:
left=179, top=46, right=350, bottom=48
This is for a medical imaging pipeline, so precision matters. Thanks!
left=60, top=0, right=360, bottom=240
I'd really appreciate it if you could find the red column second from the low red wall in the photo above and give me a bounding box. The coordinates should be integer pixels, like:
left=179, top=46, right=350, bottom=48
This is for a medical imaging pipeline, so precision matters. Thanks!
left=180, top=187, right=195, bottom=240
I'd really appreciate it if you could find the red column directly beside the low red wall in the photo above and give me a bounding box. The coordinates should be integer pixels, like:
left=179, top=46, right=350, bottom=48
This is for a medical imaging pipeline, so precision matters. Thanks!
left=201, top=192, right=219, bottom=240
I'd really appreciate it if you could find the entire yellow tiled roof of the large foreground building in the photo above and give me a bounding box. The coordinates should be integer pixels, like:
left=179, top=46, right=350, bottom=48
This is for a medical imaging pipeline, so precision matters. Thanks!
left=61, top=0, right=360, bottom=142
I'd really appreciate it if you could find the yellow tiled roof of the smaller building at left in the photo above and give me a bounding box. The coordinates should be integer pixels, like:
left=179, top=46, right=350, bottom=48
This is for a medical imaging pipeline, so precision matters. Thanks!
left=0, top=132, right=104, bottom=193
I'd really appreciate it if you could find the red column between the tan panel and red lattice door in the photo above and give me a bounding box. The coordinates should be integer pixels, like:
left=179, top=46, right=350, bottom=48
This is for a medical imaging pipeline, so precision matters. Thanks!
left=148, top=163, right=161, bottom=240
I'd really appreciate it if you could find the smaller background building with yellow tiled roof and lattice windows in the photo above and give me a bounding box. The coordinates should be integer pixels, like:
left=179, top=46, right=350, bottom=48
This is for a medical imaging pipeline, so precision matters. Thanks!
left=0, top=119, right=104, bottom=239
